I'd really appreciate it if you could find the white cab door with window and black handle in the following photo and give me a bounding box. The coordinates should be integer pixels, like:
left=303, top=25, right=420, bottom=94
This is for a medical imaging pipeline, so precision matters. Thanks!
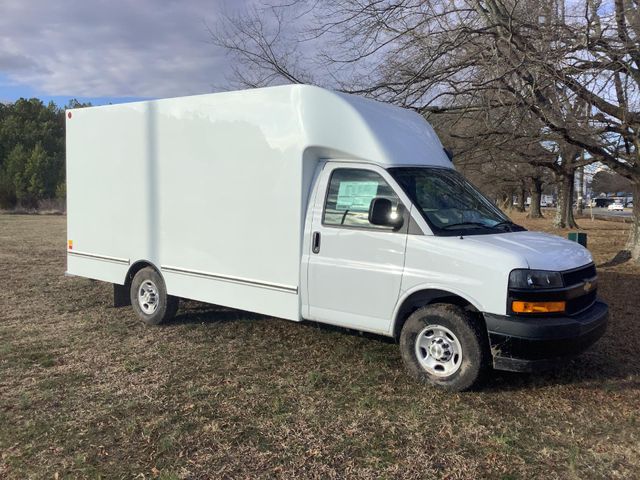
left=307, top=163, right=409, bottom=334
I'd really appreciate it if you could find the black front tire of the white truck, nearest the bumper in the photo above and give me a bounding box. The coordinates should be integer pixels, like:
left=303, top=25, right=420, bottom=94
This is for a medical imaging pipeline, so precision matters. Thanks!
left=400, top=304, right=491, bottom=392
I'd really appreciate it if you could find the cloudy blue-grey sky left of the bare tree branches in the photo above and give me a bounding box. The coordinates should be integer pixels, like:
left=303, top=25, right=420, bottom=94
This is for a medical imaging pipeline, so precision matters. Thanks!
left=0, top=0, right=254, bottom=105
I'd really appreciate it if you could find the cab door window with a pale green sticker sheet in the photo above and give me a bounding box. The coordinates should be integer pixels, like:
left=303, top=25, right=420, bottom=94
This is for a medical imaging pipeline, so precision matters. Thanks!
left=322, top=168, right=400, bottom=231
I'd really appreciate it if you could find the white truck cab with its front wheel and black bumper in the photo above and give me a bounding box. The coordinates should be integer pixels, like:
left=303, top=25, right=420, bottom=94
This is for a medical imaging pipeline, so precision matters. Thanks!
left=301, top=160, right=607, bottom=390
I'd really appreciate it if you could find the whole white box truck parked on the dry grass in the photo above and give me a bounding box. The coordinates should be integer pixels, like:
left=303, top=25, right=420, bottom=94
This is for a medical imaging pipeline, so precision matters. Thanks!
left=66, top=85, right=608, bottom=390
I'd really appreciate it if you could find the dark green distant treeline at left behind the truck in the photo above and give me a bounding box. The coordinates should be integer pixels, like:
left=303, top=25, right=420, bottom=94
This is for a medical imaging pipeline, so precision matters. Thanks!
left=0, top=98, right=88, bottom=209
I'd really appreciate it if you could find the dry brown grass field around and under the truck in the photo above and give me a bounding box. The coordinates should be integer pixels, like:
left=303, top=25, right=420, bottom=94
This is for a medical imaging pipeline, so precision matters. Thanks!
left=0, top=214, right=640, bottom=479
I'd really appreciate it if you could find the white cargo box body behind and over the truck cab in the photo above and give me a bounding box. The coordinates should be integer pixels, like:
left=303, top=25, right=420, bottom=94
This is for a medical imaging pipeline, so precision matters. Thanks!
left=67, top=86, right=448, bottom=320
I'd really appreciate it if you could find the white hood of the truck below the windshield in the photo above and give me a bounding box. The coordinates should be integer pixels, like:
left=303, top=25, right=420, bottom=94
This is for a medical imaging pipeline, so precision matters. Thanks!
left=465, top=232, right=593, bottom=271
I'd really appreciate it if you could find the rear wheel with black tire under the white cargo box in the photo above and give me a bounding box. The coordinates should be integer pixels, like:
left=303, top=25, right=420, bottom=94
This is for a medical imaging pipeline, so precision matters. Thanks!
left=130, top=267, right=179, bottom=325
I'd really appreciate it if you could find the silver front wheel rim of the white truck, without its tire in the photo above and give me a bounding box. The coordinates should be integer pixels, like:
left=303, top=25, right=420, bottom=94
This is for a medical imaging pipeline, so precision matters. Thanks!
left=416, top=324, right=462, bottom=377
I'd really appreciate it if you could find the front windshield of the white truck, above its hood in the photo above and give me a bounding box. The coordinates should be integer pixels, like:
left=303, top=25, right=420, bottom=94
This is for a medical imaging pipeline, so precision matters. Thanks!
left=389, top=167, right=524, bottom=235
